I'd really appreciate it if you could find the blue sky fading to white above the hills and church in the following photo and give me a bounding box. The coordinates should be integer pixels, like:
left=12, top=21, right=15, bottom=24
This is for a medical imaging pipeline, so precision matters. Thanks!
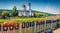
left=0, top=0, right=60, bottom=14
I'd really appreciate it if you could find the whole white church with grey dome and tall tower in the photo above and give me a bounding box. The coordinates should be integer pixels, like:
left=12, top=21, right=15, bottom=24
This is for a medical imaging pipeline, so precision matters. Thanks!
left=18, top=3, right=33, bottom=17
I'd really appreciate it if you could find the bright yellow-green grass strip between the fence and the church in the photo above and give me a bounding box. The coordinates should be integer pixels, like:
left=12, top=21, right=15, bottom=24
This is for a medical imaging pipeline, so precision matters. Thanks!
left=0, top=17, right=59, bottom=24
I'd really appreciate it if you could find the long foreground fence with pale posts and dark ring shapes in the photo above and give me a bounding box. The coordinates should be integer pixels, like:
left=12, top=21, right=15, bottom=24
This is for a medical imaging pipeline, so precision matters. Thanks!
left=0, top=20, right=60, bottom=33
